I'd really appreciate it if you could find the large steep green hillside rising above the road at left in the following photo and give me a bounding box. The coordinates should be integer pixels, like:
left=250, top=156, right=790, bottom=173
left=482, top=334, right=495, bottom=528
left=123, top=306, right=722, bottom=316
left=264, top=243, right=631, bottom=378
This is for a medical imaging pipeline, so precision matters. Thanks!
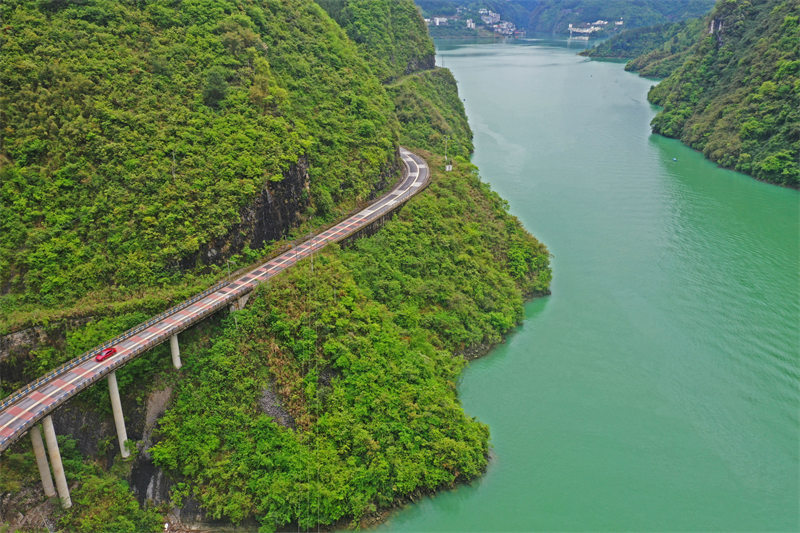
left=0, top=0, right=396, bottom=315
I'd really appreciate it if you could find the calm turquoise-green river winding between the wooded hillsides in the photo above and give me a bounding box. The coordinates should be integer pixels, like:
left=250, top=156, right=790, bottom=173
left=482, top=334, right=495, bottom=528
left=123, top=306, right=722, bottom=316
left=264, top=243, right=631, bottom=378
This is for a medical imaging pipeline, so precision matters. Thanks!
left=379, top=41, right=800, bottom=531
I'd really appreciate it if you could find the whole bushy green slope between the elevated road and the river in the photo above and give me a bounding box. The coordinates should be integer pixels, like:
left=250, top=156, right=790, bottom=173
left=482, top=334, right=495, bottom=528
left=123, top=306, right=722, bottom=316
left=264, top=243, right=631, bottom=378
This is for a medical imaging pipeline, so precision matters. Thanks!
left=153, top=155, right=549, bottom=528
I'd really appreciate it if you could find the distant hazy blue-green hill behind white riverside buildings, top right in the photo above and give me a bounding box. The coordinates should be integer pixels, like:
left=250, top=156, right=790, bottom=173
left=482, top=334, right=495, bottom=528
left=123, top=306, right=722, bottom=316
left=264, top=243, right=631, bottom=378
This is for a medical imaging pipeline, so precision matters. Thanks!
left=529, top=0, right=714, bottom=33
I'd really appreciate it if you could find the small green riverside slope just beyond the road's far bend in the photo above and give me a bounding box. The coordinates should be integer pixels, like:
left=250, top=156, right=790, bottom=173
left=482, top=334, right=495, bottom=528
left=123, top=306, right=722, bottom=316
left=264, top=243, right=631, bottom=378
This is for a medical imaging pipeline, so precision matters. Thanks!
left=387, top=68, right=473, bottom=157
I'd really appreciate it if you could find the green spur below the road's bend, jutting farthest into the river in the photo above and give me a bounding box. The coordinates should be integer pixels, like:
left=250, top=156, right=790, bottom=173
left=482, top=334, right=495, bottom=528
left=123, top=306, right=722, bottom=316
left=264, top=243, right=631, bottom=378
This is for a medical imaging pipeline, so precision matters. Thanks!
left=345, top=159, right=550, bottom=352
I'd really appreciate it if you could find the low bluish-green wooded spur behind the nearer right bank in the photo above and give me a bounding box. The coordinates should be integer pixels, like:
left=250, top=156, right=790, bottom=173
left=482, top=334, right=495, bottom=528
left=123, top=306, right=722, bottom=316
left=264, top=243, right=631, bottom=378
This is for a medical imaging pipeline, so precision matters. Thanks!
left=580, top=19, right=705, bottom=78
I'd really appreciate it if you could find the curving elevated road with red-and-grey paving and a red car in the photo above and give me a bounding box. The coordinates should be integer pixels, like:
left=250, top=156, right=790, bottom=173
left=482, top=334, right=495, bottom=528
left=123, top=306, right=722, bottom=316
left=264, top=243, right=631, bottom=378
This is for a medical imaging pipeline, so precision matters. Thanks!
left=0, top=148, right=430, bottom=453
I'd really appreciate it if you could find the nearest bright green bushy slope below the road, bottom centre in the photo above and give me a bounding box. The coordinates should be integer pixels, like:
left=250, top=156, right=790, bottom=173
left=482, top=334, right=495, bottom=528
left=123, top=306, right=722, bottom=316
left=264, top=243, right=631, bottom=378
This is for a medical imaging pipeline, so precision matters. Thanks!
left=152, top=250, right=488, bottom=528
